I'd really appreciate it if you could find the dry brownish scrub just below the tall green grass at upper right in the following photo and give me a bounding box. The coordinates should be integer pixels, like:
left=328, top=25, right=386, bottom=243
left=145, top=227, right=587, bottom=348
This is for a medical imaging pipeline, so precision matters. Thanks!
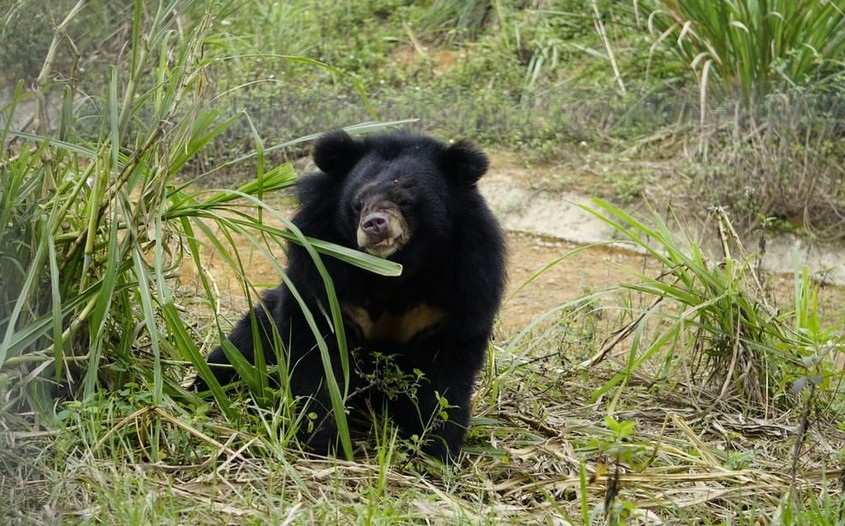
left=685, top=92, right=845, bottom=241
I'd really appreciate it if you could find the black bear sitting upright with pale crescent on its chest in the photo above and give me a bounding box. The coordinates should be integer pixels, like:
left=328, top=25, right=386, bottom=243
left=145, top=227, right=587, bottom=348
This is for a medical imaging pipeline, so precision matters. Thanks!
left=197, top=131, right=505, bottom=460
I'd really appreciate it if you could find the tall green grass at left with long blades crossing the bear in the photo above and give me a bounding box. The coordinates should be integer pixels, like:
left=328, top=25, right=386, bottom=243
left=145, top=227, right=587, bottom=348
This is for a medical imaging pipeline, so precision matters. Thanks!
left=0, top=0, right=400, bottom=458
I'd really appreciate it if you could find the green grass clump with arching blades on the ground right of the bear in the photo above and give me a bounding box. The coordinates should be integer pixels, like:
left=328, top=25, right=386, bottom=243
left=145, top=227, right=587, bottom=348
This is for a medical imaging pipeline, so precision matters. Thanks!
left=585, top=199, right=843, bottom=414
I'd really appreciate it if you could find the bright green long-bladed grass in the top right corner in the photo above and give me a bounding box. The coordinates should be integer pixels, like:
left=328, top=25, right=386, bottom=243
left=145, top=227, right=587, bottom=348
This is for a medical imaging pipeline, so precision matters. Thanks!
left=634, top=0, right=845, bottom=110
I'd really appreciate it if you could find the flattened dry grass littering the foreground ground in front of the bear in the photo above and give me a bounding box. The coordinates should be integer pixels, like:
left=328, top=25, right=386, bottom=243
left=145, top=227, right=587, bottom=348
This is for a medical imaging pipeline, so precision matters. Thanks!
left=0, top=330, right=845, bottom=524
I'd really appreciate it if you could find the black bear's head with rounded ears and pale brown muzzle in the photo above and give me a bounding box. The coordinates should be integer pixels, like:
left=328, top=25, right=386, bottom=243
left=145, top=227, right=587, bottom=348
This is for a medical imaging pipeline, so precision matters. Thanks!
left=313, top=131, right=488, bottom=262
